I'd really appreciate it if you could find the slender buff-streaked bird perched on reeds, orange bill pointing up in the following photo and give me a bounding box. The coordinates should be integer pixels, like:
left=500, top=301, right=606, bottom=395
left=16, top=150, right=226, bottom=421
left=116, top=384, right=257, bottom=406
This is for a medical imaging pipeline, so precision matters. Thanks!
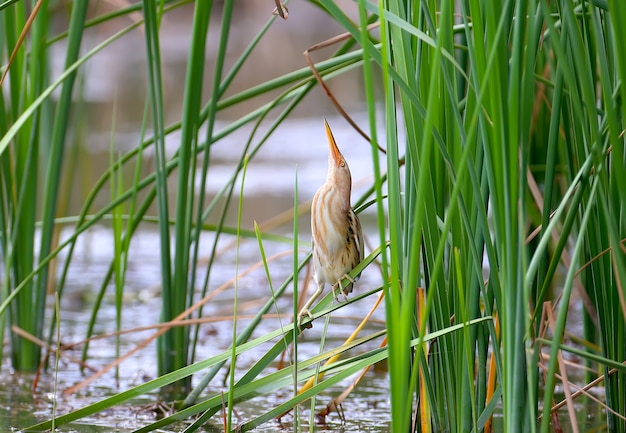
left=298, top=119, right=363, bottom=324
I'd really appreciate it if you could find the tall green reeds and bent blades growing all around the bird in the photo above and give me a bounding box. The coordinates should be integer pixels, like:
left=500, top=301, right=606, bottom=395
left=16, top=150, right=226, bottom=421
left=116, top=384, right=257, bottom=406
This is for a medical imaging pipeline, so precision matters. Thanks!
left=0, top=0, right=626, bottom=432
